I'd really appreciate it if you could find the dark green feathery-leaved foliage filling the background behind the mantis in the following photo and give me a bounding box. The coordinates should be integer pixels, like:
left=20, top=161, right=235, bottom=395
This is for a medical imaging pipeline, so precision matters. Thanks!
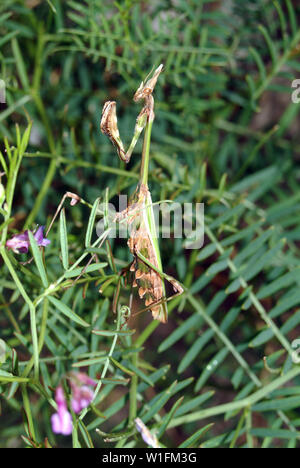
left=0, top=0, right=300, bottom=447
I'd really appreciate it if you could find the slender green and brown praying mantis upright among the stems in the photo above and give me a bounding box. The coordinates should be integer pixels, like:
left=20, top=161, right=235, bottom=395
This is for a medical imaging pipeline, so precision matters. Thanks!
left=100, top=64, right=183, bottom=323
